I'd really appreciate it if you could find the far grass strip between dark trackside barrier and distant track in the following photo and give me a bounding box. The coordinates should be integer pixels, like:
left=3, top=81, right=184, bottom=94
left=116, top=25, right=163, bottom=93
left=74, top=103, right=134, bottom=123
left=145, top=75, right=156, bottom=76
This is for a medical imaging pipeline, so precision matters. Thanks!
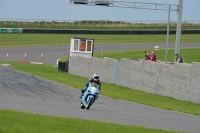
left=0, top=34, right=200, bottom=47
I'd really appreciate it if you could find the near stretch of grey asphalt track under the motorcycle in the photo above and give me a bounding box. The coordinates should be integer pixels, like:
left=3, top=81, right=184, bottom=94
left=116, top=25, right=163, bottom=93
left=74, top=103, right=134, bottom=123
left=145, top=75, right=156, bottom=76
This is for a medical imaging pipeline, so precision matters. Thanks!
left=0, top=66, right=200, bottom=133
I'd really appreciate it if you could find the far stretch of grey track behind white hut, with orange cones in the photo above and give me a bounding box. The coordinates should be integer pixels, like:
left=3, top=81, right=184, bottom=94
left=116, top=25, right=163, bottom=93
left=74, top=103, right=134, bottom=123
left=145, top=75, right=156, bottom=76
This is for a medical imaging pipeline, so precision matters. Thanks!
left=0, top=44, right=200, bottom=64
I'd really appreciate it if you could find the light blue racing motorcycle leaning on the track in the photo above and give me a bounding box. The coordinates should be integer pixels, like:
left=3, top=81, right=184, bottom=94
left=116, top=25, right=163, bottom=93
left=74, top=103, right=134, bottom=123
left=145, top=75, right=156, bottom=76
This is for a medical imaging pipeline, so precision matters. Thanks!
left=80, top=83, right=99, bottom=109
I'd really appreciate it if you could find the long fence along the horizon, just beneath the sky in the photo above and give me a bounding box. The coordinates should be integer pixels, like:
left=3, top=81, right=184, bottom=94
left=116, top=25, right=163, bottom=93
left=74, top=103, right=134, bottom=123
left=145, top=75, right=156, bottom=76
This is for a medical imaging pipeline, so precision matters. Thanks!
left=0, top=18, right=200, bottom=27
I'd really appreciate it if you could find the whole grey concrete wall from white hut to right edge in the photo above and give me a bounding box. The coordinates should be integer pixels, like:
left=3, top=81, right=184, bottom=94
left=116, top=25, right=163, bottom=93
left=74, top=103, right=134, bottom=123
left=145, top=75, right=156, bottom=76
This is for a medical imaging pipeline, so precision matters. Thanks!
left=69, top=57, right=200, bottom=103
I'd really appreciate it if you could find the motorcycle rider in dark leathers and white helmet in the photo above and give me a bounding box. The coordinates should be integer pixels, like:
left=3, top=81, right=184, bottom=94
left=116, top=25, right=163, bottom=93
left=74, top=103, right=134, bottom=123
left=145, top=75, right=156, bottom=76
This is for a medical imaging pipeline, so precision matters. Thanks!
left=81, top=73, right=101, bottom=97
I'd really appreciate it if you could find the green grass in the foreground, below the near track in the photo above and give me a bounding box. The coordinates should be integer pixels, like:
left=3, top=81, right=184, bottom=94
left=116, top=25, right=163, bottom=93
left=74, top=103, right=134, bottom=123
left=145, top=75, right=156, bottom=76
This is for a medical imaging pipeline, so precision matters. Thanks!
left=0, top=110, right=185, bottom=133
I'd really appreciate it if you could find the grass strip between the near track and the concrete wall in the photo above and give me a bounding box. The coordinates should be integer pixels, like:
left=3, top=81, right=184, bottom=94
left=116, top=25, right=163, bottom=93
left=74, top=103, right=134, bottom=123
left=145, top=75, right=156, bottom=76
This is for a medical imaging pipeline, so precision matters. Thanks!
left=0, top=61, right=200, bottom=115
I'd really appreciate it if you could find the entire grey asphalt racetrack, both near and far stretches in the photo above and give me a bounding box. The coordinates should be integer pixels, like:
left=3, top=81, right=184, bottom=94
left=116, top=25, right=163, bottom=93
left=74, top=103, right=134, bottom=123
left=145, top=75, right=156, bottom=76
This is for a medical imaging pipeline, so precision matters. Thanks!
left=0, top=44, right=200, bottom=133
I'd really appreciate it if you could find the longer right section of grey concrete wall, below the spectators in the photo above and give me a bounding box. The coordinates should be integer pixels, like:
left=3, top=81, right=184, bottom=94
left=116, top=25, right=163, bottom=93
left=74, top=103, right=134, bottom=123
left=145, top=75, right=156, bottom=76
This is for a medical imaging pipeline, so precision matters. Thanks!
left=120, top=59, right=200, bottom=103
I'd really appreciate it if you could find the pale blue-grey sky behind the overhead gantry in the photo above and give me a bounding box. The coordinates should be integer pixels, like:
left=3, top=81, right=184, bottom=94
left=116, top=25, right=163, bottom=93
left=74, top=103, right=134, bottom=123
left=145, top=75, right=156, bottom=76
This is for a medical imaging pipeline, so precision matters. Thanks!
left=0, top=0, right=200, bottom=21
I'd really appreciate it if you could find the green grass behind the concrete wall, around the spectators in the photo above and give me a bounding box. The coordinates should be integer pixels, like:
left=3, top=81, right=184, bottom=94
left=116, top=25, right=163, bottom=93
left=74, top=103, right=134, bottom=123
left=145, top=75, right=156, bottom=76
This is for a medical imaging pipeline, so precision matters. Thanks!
left=94, top=48, right=200, bottom=63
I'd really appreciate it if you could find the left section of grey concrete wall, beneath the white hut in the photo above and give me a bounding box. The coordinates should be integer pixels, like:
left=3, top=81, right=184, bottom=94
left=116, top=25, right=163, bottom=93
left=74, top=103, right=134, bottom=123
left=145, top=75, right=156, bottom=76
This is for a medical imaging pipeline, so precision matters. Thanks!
left=69, top=56, right=117, bottom=83
